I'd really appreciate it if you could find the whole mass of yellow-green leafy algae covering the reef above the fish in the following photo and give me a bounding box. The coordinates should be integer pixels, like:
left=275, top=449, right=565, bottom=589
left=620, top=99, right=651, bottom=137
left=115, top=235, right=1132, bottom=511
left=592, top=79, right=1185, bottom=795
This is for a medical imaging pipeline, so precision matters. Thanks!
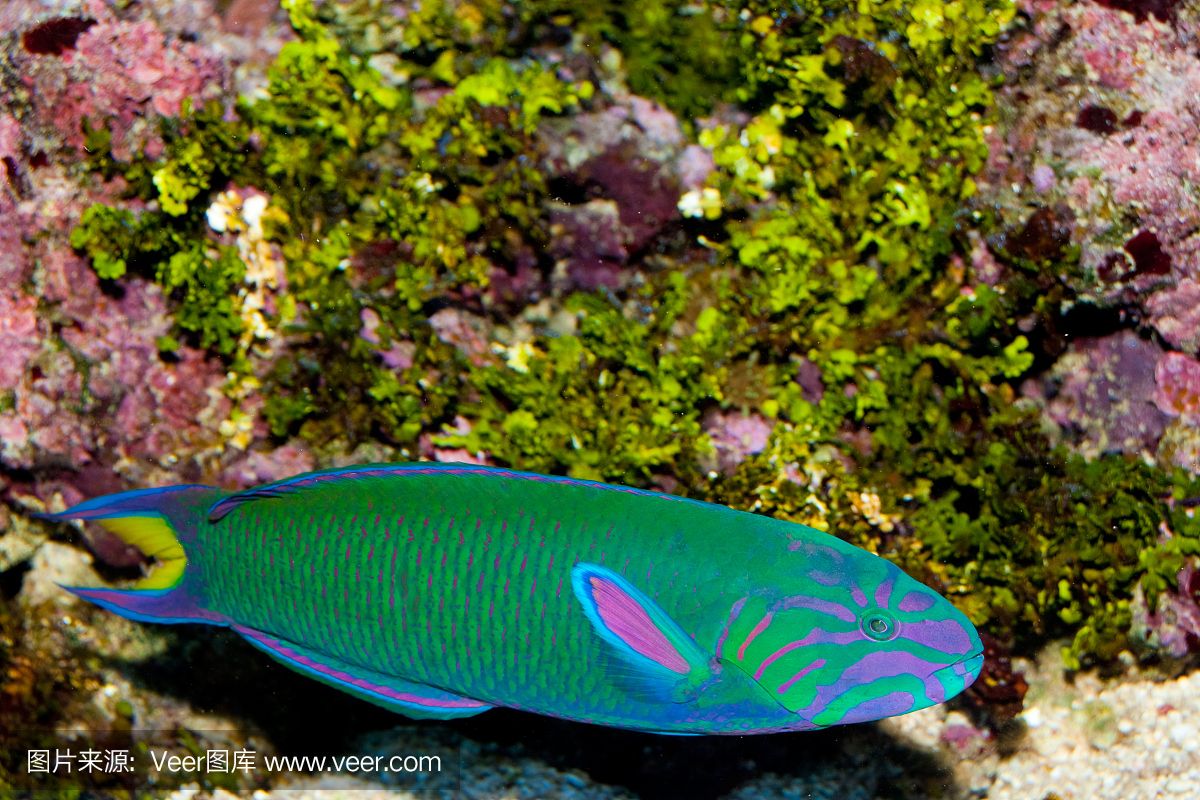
left=60, top=0, right=1200, bottom=667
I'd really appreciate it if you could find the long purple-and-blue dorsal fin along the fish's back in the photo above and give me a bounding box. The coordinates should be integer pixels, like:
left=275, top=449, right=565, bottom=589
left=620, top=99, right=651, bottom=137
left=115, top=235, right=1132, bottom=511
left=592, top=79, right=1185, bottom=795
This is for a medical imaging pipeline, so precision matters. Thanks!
left=209, top=462, right=720, bottom=523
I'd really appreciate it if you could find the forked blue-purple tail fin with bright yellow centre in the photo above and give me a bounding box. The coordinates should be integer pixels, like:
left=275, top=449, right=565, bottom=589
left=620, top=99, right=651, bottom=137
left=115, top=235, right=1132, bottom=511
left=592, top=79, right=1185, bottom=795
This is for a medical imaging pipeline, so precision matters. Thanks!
left=40, top=486, right=224, bottom=622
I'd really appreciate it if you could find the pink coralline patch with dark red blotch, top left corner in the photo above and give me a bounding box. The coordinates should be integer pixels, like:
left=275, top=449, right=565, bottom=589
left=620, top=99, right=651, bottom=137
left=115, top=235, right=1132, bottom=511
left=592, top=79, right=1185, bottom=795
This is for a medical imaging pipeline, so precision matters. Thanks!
left=14, top=2, right=227, bottom=161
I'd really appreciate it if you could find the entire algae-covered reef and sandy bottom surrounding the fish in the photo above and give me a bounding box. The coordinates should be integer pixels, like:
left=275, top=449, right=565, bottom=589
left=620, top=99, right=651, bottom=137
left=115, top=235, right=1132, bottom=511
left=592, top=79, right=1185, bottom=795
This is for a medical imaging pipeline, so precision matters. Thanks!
left=0, top=0, right=1200, bottom=800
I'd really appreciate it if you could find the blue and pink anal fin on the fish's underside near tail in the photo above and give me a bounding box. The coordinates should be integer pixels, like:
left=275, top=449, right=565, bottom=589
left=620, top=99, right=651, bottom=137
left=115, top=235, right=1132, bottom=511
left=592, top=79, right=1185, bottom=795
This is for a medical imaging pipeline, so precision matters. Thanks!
left=233, top=625, right=493, bottom=720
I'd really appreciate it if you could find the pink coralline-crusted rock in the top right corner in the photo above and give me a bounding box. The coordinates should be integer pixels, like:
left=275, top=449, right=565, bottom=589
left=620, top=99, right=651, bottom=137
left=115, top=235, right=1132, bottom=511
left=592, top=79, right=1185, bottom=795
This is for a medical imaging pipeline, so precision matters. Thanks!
left=980, top=2, right=1200, bottom=353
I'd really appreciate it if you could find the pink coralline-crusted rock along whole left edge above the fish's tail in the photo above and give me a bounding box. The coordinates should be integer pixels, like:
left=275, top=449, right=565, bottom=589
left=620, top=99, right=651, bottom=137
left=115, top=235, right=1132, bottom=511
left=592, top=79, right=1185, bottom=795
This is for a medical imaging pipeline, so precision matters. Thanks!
left=0, top=0, right=292, bottom=513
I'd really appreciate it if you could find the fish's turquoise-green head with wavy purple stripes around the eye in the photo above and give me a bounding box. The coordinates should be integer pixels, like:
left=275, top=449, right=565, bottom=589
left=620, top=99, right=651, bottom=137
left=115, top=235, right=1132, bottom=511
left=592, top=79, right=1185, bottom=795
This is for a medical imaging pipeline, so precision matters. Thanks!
left=724, top=537, right=983, bottom=728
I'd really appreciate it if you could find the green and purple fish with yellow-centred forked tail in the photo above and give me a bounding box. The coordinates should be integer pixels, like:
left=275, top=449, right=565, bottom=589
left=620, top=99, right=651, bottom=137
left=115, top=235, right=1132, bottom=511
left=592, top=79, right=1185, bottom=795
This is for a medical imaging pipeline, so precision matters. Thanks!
left=49, top=463, right=983, bottom=734
